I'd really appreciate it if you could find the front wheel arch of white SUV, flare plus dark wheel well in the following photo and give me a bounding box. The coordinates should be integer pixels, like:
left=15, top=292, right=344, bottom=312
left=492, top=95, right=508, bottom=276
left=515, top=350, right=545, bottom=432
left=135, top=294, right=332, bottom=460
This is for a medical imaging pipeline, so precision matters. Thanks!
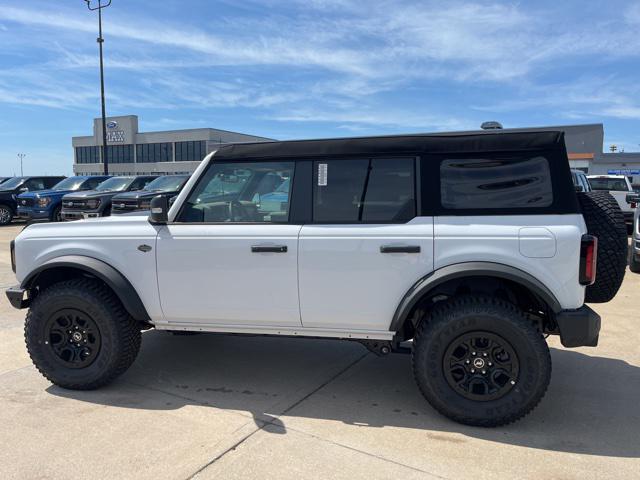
left=20, top=255, right=151, bottom=323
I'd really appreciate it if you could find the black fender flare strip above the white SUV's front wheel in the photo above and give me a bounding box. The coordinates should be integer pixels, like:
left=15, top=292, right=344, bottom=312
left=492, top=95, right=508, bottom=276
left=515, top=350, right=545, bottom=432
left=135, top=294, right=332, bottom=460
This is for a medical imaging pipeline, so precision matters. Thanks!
left=20, top=255, right=151, bottom=323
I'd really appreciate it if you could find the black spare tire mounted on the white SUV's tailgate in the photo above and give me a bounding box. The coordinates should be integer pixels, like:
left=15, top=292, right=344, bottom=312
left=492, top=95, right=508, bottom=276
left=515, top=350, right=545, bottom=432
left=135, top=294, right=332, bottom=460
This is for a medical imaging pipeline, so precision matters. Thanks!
left=577, top=191, right=628, bottom=303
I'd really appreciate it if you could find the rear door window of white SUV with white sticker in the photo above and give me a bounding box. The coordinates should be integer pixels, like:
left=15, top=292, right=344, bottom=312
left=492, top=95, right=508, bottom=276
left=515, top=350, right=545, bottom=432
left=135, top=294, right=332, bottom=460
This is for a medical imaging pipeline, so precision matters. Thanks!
left=313, top=158, right=416, bottom=223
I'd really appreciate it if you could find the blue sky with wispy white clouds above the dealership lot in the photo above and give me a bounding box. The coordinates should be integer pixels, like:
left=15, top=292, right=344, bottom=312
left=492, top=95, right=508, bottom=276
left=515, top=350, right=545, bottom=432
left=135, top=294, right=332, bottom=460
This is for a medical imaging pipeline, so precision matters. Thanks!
left=0, top=0, right=640, bottom=175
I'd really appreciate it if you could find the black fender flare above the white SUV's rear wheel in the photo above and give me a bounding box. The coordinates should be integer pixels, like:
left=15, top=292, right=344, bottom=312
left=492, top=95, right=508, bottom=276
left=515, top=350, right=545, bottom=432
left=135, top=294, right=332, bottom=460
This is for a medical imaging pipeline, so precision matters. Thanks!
left=389, top=262, right=562, bottom=332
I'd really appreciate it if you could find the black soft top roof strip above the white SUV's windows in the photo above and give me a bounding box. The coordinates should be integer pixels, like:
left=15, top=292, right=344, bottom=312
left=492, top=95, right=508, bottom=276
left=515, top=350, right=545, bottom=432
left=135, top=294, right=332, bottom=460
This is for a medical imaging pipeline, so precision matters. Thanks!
left=214, top=131, right=564, bottom=160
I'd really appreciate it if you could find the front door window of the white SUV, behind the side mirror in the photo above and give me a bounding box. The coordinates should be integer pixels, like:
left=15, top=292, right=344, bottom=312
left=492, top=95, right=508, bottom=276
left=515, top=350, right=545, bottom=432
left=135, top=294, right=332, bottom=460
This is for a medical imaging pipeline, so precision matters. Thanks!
left=177, top=162, right=295, bottom=223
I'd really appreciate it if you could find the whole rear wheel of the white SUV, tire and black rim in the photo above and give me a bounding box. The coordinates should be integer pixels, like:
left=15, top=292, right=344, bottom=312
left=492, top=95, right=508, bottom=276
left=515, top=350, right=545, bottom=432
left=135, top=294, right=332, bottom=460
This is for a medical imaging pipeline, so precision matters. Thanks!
left=413, top=296, right=551, bottom=427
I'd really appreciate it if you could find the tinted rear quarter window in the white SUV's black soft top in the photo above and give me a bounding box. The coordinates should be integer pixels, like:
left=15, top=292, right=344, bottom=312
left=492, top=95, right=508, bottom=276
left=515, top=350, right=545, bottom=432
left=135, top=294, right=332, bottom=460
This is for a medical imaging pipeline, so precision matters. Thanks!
left=440, top=154, right=553, bottom=210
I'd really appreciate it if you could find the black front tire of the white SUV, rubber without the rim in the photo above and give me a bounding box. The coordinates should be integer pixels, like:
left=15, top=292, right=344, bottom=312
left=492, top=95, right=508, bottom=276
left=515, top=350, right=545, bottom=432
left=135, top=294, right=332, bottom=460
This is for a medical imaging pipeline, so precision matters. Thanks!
left=24, top=278, right=141, bottom=390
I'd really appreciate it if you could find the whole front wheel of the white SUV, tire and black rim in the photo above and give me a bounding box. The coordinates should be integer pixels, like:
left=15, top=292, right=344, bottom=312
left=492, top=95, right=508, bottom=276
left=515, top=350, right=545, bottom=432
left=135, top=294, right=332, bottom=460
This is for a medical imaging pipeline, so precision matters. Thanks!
left=24, top=278, right=141, bottom=390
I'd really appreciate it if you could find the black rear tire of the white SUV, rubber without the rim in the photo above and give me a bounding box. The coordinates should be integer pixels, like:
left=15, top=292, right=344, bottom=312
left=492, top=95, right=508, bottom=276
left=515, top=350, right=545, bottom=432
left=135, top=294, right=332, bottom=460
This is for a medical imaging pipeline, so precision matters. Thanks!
left=413, top=295, right=551, bottom=427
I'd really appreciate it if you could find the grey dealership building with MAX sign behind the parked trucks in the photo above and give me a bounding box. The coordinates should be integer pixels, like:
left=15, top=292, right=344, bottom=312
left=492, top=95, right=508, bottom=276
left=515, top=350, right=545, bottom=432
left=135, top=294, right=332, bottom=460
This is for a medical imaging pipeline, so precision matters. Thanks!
left=71, top=115, right=271, bottom=175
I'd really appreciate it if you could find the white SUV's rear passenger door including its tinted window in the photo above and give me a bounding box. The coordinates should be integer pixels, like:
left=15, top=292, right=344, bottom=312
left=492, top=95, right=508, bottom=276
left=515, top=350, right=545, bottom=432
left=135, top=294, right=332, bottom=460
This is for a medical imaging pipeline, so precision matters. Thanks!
left=299, top=157, right=433, bottom=331
